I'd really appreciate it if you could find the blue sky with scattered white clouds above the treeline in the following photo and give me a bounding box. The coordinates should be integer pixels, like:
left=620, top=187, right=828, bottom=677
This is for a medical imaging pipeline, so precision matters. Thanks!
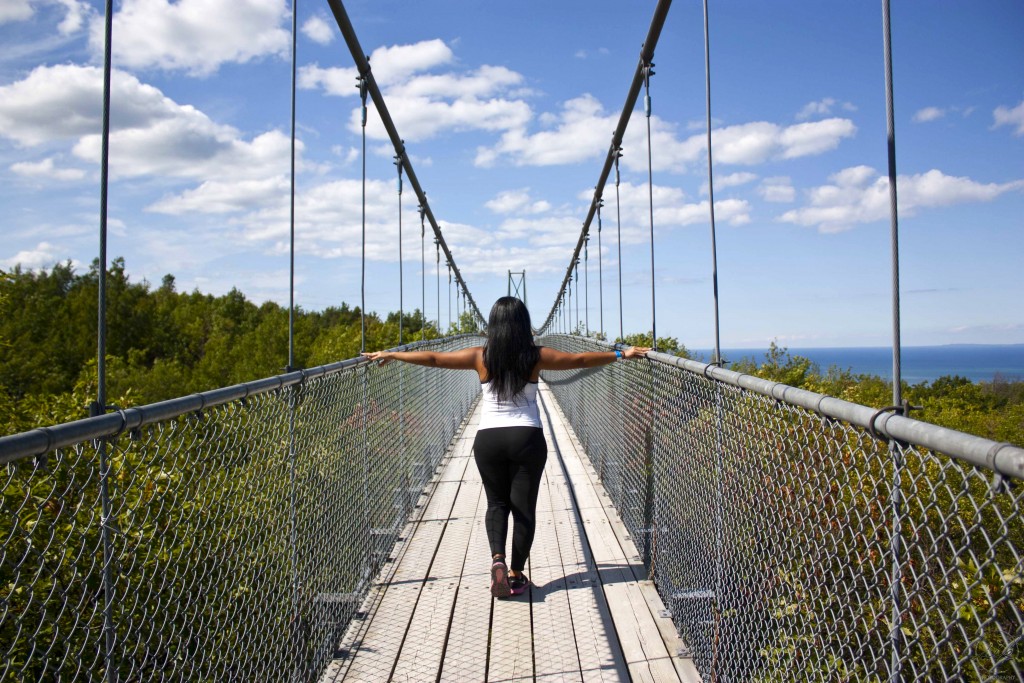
left=0, top=0, right=1024, bottom=348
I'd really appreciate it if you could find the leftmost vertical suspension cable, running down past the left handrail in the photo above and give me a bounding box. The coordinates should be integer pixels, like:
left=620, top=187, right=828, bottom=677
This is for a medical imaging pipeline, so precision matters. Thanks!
left=95, top=0, right=118, bottom=683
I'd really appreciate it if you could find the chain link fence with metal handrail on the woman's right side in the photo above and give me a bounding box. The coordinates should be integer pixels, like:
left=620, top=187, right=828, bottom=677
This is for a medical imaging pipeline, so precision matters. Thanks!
left=543, top=335, right=1024, bottom=682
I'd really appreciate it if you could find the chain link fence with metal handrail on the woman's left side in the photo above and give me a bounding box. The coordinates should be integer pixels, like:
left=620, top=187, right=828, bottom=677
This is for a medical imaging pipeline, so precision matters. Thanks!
left=0, top=335, right=480, bottom=681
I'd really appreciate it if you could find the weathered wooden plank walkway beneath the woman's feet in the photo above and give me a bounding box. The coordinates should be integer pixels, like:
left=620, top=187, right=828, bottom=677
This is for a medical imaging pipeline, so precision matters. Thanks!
left=322, top=383, right=700, bottom=683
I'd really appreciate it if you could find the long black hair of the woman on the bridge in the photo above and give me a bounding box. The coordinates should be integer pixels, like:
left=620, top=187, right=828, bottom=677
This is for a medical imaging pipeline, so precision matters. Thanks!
left=483, top=297, right=541, bottom=401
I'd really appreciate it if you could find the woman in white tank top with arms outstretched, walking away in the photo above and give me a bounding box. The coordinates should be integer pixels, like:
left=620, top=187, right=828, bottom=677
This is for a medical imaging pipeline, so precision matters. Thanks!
left=364, top=297, right=650, bottom=598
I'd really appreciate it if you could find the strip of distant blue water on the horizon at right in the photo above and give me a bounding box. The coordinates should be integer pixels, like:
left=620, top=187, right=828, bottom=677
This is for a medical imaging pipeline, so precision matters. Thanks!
left=692, top=344, right=1024, bottom=384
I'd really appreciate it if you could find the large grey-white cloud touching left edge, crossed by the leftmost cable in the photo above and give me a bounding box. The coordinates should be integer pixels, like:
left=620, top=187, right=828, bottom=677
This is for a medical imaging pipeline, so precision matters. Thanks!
left=0, top=65, right=304, bottom=219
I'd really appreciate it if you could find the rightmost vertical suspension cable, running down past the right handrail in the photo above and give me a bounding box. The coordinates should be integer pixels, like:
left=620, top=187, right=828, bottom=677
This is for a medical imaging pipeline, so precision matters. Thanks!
left=872, top=0, right=906, bottom=683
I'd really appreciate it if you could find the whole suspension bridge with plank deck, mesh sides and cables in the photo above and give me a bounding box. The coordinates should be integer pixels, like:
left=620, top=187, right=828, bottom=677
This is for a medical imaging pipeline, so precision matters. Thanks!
left=0, top=0, right=1024, bottom=681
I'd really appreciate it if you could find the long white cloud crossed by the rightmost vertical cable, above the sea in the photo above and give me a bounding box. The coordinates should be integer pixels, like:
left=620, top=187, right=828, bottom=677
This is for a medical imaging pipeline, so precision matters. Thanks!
left=778, top=166, right=1024, bottom=232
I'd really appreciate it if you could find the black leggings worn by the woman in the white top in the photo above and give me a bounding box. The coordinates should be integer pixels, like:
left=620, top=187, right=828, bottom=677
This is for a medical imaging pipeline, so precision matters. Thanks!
left=473, top=427, right=548, bottom=571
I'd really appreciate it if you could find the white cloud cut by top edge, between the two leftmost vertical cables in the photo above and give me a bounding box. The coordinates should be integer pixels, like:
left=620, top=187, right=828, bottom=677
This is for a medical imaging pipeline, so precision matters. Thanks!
left=89, top=0, right=291, bottom=76
